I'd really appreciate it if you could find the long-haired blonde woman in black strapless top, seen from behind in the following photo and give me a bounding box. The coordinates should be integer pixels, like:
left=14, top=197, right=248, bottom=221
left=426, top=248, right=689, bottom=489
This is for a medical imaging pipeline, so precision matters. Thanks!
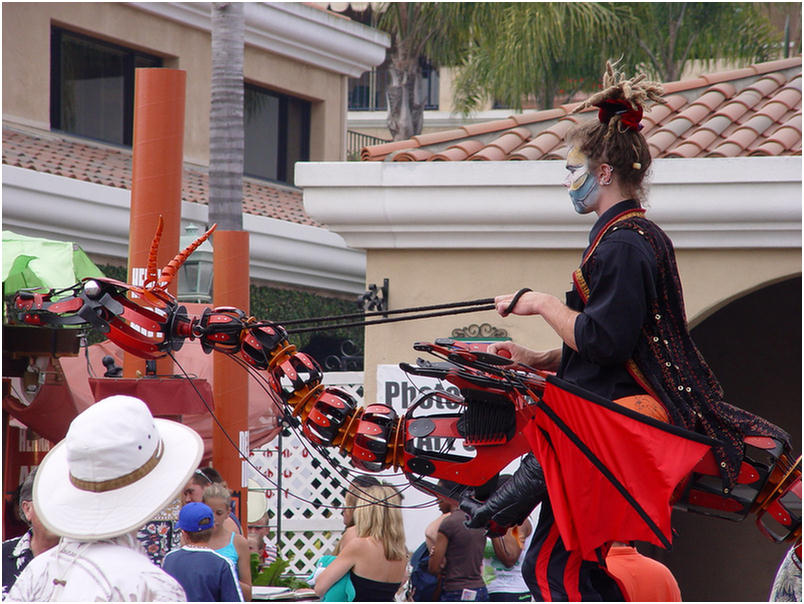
left=315, top=485, right=408, bottom=602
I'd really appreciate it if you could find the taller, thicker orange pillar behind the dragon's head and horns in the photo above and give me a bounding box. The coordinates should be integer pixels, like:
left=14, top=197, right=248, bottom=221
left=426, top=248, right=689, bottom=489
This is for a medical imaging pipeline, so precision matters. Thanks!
left=123, top=68, right=187, bottom=377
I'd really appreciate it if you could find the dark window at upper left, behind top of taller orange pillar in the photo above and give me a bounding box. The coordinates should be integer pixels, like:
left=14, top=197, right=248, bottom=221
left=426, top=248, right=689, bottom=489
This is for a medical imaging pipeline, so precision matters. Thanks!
left=50, top=27, right=162, bottom=145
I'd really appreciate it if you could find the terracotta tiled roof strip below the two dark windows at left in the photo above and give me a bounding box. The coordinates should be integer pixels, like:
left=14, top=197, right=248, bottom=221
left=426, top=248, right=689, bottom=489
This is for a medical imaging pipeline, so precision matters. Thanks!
left=3, top=124, right=321, bottom=226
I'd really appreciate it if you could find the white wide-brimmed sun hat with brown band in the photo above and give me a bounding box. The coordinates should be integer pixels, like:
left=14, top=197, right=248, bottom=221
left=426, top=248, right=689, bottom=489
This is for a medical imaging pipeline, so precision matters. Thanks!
left=33, top=395, right=203, bottom=541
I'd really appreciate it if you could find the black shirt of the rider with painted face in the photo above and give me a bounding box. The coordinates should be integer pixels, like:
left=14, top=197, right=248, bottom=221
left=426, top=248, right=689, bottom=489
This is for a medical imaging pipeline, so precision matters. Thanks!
left=558, top=200, right=657, bottom=400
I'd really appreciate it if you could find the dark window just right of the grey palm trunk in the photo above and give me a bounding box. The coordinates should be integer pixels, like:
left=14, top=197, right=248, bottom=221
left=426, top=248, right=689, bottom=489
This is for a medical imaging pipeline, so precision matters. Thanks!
left=243, top=84, right=310, bottom=184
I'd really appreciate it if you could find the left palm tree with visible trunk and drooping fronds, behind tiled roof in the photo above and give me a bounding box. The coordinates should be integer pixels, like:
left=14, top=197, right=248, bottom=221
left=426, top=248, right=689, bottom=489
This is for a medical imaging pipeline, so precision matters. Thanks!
left=377, top=2, right=627, bottom=140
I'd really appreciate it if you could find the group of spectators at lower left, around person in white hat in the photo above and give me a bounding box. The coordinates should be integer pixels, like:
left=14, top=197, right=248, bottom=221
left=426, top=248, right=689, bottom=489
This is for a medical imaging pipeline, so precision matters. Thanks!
left=3, top=396, right=262, bottom=602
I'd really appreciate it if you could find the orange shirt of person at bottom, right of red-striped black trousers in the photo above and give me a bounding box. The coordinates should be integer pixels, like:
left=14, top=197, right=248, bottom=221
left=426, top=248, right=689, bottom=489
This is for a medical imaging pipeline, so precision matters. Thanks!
left=606, top=546, right=681, bottom=602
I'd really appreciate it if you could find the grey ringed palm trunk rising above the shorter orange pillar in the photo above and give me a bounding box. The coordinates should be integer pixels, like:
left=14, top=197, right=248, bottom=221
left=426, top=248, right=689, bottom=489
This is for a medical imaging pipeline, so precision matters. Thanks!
left=209, top=2, right=245, bottom=231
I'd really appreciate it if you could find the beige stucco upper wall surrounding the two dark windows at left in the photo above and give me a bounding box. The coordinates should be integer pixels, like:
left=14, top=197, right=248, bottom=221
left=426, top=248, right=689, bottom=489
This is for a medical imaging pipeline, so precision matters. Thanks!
left=2, top=2, right=346, bottom=164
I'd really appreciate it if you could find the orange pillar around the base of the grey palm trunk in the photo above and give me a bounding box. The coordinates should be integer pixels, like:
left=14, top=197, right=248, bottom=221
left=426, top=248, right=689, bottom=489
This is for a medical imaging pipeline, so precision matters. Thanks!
left=212, top=230, right=249, bottom=530
